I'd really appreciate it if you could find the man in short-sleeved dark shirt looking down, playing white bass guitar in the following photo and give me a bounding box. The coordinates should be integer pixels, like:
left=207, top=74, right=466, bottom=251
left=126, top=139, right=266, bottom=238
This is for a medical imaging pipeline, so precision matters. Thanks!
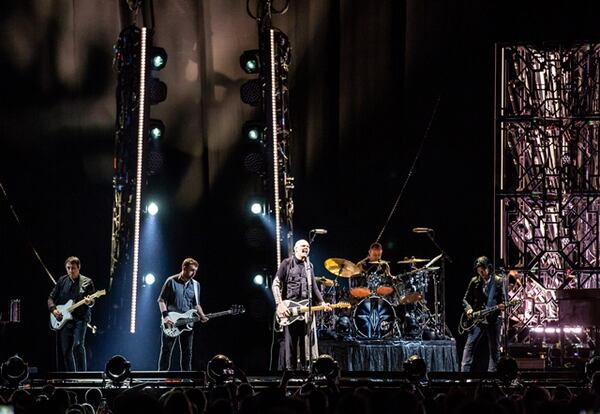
left=158, top=258, right=208, bottom=371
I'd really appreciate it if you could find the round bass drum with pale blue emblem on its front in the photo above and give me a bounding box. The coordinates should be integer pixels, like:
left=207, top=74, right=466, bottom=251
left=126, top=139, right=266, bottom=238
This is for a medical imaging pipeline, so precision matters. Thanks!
left=352, top=296, right=396, bottom=339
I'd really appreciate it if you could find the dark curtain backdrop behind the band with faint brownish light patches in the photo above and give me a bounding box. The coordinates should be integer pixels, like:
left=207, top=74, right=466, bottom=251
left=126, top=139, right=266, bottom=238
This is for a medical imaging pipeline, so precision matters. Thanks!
left=0, top=0, right=600, bottom=371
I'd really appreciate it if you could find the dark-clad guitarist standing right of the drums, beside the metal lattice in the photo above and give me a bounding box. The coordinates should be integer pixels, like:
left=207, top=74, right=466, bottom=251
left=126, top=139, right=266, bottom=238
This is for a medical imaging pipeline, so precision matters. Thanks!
left=461, top=256, right=506, bottom=372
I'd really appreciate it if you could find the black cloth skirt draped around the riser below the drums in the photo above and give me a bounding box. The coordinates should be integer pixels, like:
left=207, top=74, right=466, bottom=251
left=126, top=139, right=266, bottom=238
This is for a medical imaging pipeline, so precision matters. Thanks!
left=319, top=339, right=459, bottom=372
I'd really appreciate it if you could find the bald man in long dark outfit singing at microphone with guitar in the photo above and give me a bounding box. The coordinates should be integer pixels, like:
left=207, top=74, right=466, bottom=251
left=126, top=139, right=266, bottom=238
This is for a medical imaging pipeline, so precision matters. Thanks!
left=272, top=240, right=331, bottom=370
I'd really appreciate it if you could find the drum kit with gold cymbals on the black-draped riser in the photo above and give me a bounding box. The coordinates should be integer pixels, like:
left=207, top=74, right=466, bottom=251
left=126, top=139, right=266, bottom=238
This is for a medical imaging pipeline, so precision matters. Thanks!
left=316, top=257, right=440, bottom=339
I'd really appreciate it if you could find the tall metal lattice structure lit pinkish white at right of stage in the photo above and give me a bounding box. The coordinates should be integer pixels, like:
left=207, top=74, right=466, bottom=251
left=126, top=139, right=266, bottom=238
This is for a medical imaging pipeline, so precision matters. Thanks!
left=495, top=42, right=600, bottom=340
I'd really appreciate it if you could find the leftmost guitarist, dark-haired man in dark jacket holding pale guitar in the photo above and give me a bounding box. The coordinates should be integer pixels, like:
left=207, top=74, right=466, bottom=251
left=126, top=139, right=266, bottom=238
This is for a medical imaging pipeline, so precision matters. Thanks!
left=48, top=256, right=95, bottom=371
